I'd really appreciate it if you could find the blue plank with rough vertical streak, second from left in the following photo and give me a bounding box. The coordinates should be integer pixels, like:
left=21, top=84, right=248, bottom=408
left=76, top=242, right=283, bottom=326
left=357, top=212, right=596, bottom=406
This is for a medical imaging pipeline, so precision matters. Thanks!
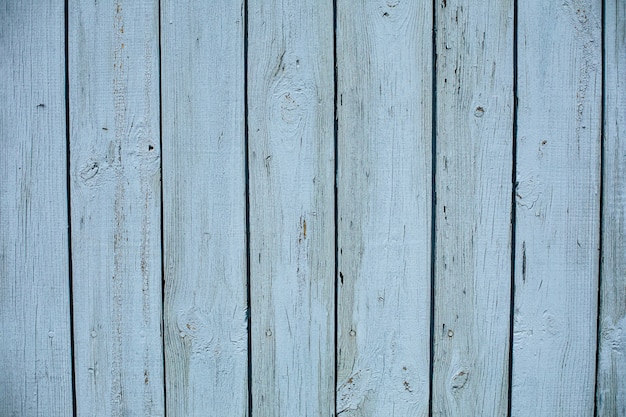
left=69, top=0, right=164, bottom=416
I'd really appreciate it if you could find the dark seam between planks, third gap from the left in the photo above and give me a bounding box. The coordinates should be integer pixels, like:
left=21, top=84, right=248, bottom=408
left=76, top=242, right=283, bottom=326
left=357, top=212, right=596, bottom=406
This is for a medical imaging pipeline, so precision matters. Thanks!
left=242, top=0, right=253, bottom=417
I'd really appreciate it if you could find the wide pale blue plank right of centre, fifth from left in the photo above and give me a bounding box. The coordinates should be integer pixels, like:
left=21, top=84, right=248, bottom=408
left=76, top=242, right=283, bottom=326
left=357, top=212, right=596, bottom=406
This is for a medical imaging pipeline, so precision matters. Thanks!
left=337, top=1, right=433, bottom=416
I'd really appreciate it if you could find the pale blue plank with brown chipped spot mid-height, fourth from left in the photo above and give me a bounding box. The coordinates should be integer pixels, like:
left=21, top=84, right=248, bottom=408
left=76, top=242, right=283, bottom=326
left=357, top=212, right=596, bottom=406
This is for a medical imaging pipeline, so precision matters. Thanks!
left=248, top=0, right=335, bottom=416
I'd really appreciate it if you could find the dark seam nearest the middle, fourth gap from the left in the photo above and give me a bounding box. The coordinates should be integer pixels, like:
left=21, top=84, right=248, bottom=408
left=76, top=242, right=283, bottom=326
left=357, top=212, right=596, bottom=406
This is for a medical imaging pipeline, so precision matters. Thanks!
left=333, top=0, right=339, bottom=416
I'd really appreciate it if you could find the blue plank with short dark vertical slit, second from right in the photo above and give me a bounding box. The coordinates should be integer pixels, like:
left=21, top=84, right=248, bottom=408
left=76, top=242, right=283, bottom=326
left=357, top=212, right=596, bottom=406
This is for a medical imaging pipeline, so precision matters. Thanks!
left=512, top=0, right=602, bottom=416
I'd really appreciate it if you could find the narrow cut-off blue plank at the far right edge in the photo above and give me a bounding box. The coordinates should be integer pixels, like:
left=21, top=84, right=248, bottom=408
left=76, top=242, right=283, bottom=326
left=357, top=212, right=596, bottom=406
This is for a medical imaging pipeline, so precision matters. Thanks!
left=596, top=0, right=626, bottom=417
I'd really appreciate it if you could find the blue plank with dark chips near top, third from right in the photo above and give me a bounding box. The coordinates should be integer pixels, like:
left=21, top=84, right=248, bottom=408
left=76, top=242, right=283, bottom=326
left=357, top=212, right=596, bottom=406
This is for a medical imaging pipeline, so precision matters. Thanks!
left=433, top=0, right=513, bottom=416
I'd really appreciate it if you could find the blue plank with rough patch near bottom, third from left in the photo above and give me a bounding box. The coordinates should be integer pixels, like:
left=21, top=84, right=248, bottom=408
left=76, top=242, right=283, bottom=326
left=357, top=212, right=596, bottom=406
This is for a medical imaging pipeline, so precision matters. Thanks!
left=161, top=0, right=248, bottom=416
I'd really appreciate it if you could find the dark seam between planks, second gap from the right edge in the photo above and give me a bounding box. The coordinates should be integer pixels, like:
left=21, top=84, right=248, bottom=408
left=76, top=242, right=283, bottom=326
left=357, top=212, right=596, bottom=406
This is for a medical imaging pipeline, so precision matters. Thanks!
left=507, top=0, right=518, bottom=417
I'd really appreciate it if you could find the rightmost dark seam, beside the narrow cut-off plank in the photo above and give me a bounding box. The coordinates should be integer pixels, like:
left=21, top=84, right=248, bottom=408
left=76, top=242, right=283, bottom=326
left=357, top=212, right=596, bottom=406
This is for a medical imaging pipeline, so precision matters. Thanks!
left=593, top=1, right=606, bottom=417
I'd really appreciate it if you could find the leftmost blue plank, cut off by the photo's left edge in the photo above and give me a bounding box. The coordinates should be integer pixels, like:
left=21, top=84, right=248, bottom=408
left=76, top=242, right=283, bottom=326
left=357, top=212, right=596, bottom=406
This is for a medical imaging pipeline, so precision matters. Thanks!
left=0, top=1, right=72, bottom=416
